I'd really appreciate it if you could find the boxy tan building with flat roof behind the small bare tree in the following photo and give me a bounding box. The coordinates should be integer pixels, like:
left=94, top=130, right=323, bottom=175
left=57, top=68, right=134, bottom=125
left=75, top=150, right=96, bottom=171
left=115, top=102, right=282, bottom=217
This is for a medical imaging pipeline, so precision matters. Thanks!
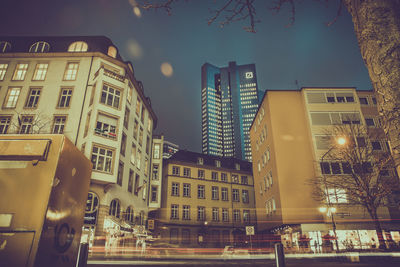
left=250, top=88, right=400, bottom=251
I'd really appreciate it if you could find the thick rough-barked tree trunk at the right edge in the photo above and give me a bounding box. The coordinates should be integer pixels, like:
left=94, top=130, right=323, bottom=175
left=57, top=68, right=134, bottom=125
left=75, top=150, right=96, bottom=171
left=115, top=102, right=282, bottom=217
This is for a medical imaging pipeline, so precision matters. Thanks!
left=344, top=0, right=400, bottom=176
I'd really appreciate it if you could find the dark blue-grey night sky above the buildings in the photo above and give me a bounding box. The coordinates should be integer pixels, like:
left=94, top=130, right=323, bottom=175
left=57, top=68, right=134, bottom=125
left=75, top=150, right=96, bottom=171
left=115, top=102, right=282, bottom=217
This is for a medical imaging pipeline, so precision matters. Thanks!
left=0, top=0, right=372, bottom=152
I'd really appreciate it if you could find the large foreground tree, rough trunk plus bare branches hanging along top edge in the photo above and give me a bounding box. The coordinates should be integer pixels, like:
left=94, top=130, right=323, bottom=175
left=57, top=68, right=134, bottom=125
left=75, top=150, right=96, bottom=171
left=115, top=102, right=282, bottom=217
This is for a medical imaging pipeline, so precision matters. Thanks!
left=130, top=0, right=400, bottom=176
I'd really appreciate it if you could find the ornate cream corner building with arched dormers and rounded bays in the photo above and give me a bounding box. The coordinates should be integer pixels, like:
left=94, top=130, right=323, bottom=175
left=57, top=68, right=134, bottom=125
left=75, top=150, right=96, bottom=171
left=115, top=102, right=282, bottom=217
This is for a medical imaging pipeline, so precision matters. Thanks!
left=0, top=36, right=157, bottom=249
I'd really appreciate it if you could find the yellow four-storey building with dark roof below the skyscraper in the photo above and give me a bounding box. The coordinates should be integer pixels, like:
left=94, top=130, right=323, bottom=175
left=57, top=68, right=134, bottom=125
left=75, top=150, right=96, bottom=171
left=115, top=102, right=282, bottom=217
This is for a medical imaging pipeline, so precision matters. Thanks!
left=156, top=150, right=256, bottom=247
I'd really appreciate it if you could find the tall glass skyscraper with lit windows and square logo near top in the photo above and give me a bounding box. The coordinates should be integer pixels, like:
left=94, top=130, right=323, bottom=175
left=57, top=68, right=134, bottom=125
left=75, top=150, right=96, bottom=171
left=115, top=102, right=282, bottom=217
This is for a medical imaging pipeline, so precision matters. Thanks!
left=201, top=62, right=259, bottom=161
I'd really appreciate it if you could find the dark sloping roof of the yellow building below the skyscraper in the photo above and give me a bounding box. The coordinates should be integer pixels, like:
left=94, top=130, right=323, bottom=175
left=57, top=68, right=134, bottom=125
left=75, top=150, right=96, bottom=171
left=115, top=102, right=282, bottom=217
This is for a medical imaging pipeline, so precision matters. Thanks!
left=166, top=150, right=252, bottom=172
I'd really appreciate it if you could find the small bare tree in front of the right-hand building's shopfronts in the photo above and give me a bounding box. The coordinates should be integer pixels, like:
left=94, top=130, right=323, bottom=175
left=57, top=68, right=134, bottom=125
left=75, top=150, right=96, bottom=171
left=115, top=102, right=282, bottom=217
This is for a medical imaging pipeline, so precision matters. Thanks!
left=310, top=124, right=399, bottom=248
